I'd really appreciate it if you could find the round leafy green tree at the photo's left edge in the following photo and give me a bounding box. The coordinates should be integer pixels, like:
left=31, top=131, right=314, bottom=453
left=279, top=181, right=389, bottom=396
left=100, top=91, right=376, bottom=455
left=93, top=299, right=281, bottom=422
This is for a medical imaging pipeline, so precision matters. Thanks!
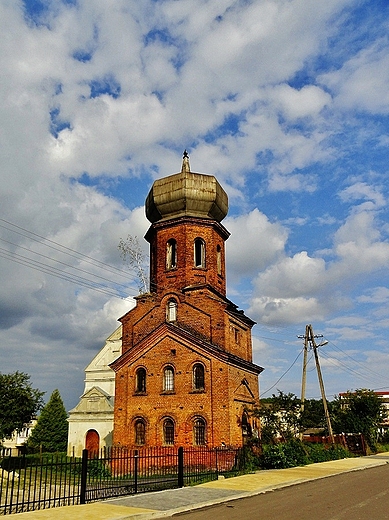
left=0, top=372, right=44, bottom=443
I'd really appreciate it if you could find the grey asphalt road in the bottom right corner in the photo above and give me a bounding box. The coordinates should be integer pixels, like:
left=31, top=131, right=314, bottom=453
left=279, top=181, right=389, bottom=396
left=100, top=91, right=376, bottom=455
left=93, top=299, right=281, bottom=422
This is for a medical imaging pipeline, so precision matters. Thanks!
left=173, top=464, right=389, bottom=520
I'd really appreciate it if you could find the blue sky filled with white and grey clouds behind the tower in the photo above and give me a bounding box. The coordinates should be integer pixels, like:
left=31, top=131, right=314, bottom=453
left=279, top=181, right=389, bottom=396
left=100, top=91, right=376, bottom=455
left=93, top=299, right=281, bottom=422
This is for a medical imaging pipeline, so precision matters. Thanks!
left=0, top=0, right=389, bottom=410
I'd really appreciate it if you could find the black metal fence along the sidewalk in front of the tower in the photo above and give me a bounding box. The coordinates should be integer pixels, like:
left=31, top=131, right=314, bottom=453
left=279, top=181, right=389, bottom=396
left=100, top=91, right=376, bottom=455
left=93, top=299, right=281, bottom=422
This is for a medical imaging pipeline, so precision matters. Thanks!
left=0, top=447, right=244, bottom=515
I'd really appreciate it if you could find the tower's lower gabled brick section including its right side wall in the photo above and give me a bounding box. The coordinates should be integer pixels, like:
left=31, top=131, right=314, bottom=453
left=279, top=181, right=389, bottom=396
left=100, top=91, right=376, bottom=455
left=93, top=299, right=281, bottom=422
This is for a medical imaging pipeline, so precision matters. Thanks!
left=111, top=323, right=261, bottom=447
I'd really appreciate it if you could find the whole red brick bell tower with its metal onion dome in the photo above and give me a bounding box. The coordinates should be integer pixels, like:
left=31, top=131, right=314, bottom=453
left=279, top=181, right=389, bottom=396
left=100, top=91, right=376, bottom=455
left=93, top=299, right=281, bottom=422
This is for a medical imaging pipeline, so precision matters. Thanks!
left=111, top=151, right=263, bottom=447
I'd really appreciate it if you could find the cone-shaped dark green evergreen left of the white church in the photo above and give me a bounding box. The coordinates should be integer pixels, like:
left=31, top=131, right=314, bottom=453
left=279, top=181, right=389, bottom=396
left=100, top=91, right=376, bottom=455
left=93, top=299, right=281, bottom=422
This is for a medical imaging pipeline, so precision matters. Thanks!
left=27, top=390, right=69, bottom=452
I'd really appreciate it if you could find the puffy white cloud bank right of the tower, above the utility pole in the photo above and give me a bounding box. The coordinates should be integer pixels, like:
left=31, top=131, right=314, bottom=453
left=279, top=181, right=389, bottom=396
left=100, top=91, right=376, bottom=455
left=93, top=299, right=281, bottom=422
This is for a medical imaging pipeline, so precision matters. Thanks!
left=249, top=206, right=389, bottom=324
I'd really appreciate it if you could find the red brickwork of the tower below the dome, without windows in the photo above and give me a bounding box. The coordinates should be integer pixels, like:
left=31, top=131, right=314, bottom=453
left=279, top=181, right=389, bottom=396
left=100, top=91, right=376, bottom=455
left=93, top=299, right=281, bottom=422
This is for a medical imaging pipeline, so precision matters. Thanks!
left=113, top=213, right=259, bottom=447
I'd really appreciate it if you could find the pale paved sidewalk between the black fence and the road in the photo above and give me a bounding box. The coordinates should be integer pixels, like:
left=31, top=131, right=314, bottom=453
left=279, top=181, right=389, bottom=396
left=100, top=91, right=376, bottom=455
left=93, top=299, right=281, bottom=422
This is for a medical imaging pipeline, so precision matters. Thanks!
left=12, top=453, right=389, bottom=520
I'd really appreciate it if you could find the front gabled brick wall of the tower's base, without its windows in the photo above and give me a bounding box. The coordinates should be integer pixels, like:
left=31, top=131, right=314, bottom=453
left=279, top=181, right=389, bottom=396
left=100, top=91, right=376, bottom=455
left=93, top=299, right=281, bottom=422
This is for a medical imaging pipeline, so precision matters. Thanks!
left=110, top=338, right=241, bottom=446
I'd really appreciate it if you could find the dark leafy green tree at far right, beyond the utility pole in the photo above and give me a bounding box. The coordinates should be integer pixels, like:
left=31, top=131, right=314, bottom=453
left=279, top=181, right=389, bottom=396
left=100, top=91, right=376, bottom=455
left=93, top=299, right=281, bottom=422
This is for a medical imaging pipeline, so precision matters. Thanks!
left=333, top=388, right=387, bottom=451
